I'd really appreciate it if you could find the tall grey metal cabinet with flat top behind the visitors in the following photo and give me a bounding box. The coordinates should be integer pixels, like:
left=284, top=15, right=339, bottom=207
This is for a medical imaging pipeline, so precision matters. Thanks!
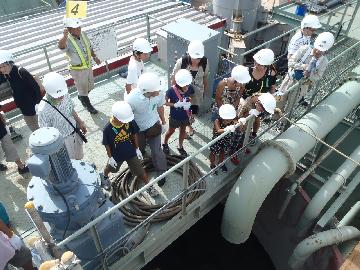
left=158, top=18, right=220, bottom=114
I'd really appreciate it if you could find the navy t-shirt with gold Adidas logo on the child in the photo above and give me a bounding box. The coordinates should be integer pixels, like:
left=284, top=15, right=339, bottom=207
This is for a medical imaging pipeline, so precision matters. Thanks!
left=102, top=120, right=139, bottom=162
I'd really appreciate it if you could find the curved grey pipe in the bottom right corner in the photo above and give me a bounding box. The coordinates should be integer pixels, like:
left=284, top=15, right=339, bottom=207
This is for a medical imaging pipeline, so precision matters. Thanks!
left=289, top=226, right=360, bottom=270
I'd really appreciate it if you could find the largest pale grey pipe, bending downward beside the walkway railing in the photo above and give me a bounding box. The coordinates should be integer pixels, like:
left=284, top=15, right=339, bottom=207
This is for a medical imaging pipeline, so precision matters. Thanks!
left=221, top=74, right=360, bottom=244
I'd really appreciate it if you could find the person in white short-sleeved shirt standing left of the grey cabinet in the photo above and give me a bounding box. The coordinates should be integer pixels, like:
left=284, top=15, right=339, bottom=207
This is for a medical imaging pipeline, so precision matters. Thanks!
left=124, top=38, right=152, bottom=99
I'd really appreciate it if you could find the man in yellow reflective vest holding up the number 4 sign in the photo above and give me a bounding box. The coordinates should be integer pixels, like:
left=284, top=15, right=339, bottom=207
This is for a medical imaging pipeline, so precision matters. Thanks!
left=58, top=18, right=101, bottom=114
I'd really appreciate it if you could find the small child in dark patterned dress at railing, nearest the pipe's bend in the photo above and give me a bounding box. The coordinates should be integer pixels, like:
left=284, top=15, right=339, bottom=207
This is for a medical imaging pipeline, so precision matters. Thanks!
left=209, top=104, right=237, bottom=175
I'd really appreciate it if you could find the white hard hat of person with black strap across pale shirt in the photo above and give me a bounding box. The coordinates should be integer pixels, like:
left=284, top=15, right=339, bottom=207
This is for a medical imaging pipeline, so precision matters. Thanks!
left=43, top=72, right=68, bottom=98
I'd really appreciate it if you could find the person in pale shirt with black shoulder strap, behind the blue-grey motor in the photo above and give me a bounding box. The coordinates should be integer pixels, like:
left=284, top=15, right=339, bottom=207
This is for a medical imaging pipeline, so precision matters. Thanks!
left=39, top=72, right=86, bottom=160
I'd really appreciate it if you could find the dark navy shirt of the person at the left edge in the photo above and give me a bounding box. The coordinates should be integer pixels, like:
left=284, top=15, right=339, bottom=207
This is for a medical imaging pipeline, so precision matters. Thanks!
left=0, top=65, right=41, bottom=116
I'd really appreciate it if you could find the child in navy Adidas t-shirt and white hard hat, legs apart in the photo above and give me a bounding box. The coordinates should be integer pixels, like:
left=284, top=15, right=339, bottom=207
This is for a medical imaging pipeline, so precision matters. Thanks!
left=102, top=101, right=159, bottom=197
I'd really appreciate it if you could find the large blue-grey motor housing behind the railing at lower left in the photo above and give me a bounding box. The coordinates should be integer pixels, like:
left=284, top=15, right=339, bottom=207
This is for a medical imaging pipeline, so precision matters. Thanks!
left=27, top=127, right=125, bottom=269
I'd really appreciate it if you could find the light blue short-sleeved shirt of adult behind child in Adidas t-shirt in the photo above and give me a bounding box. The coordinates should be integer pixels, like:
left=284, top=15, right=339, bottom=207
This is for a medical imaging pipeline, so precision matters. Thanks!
left=127, top=88, right=165, bottom=131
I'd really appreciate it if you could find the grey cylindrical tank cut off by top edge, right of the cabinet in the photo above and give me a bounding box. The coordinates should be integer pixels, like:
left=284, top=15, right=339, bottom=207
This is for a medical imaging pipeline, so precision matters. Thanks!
left=213, top=0, right=261, bottom=33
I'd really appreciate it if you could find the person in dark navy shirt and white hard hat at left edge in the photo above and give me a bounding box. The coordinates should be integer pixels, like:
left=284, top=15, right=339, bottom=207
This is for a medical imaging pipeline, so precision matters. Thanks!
left=0, top=50, right=43, bottom=131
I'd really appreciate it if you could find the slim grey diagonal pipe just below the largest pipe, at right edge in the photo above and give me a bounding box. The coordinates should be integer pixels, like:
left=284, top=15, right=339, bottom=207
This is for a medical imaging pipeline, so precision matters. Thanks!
left=297, top=146, right=360, bottom=236
